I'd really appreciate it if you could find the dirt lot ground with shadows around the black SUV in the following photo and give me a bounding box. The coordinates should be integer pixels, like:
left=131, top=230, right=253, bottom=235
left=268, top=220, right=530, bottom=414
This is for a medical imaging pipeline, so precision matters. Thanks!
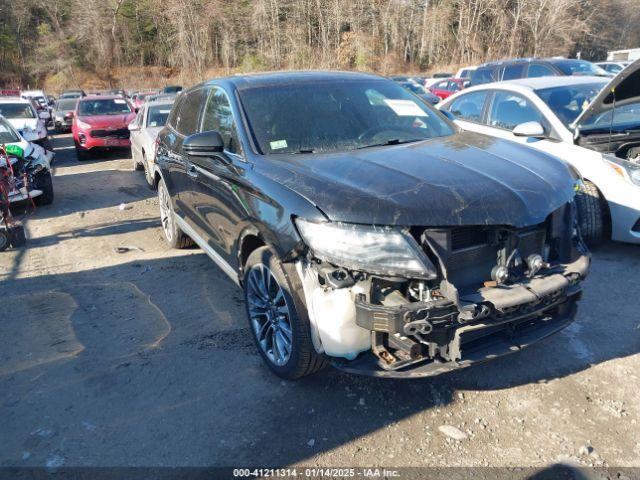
left=0, top=136, right=640, bottom=469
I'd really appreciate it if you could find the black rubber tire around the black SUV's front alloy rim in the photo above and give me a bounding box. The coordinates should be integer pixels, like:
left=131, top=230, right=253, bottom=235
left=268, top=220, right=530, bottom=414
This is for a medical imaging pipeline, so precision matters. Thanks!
left=244, top=247, right=327, bottom=380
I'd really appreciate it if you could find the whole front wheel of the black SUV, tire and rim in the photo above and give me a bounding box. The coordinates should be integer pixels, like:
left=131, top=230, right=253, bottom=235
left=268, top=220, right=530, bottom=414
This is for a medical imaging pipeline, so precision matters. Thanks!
left=244, top=247, right=326, bottom=380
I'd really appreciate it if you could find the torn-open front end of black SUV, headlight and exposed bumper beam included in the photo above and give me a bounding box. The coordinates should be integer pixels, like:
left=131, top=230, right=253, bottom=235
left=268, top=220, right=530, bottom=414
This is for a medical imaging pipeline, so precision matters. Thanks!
left=296, top=203, right=590, bottom=377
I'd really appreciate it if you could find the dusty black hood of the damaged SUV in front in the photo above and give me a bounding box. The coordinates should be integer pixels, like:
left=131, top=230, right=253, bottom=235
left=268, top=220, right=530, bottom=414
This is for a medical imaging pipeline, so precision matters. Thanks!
left=256, top=132, right=576, bottom=227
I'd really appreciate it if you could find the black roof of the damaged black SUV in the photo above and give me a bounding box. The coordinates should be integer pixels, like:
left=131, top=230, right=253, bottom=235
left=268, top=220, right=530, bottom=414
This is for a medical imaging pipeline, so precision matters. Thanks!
left=200, top=70, right=380, bottom=90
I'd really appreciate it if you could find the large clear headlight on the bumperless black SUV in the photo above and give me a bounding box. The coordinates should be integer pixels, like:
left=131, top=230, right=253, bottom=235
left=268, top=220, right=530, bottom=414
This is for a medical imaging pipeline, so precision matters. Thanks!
left=296, top=218, right=437, bottom=280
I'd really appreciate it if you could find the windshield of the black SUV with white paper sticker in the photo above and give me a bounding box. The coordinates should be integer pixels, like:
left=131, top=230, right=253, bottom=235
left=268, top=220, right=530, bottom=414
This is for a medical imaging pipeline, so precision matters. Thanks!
left=240, top=80, right=454, bottom=154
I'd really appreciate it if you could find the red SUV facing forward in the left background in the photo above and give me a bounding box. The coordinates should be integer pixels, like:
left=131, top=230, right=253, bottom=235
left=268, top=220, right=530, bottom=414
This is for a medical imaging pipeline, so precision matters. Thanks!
left=71, top=95, right=136, bottom=160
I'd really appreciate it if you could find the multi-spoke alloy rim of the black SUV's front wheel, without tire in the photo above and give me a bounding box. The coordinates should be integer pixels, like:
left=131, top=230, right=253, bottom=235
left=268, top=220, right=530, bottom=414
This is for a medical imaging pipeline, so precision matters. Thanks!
left=245, top=264, right=293, bottom=366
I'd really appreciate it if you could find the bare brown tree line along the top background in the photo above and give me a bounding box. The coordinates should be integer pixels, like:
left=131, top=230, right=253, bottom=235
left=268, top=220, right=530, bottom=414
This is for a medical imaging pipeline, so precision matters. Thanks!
left=0, top=0, right=640, bottom=86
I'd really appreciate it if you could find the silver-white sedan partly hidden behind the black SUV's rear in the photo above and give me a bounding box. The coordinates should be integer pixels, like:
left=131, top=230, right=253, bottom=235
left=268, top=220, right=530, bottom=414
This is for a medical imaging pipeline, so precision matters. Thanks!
left=129, top=97, right=175, bottom=187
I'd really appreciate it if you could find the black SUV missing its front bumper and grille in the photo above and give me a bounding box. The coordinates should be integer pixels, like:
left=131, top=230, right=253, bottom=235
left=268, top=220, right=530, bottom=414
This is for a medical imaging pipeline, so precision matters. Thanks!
left=155, top=72, right=589, bottom=379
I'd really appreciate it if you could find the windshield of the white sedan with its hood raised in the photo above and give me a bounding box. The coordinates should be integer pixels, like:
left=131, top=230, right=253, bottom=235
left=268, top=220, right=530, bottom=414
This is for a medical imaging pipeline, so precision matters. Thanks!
left=536, top=82, right=607, bottom=127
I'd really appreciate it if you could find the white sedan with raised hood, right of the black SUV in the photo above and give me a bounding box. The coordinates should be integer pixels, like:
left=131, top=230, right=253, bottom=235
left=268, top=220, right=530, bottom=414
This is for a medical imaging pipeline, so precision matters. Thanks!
left=438, top=61, right=640, bottom=245
